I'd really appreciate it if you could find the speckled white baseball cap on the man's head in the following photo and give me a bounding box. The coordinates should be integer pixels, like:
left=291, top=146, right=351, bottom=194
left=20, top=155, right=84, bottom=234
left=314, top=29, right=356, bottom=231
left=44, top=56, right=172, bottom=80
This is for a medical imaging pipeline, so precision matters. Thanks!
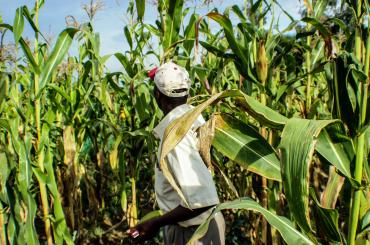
left=154, top=61, right=191, bottom=97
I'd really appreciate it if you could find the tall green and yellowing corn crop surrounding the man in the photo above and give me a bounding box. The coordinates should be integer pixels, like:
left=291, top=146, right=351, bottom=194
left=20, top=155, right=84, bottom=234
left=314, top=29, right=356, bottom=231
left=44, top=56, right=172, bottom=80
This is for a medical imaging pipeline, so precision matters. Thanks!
left=0, top=0, right=370, bottom=245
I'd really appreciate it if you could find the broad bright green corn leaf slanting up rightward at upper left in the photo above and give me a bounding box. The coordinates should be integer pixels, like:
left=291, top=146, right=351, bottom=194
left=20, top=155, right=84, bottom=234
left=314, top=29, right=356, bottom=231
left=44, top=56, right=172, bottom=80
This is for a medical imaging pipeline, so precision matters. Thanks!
left=35, top=28, right=78, bottom=97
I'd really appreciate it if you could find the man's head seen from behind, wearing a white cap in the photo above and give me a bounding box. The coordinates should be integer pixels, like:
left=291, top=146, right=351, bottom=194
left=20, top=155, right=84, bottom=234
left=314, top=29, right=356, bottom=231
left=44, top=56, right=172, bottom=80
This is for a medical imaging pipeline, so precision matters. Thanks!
left=154, top=62, right=191, bottom=114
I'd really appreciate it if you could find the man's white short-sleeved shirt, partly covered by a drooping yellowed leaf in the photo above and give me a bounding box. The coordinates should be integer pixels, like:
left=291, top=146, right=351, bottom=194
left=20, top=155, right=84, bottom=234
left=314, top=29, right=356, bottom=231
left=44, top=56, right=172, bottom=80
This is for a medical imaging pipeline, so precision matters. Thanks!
left=154, top=104, right=219, bottom=227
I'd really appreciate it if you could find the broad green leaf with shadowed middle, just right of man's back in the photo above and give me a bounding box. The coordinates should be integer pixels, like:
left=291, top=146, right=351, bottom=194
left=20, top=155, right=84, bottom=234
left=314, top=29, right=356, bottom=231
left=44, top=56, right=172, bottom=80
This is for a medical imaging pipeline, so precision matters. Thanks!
left=212, top=115, right=281, bottom=181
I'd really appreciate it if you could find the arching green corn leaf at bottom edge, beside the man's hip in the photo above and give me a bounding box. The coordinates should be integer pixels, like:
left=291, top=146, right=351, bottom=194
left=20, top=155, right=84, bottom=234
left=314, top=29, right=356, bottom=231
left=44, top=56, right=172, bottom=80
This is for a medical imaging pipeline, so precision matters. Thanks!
left=188, top=197, right=315, bottom=245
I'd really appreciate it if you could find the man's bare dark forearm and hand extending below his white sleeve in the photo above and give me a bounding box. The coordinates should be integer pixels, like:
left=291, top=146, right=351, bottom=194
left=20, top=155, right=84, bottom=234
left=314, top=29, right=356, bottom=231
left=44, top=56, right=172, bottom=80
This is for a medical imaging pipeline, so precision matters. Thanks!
left=129, top=205, right=213, bottom=242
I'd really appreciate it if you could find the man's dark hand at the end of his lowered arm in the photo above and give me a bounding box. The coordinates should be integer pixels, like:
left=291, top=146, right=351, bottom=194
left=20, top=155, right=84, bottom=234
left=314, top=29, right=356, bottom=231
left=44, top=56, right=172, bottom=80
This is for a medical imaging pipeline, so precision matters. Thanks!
left=127, top=218, right=160, bottom=243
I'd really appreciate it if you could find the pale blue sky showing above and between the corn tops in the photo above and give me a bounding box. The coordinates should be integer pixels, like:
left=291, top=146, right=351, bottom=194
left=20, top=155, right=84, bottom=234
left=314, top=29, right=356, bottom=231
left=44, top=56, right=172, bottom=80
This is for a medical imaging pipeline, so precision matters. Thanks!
left=0, top=0, right=302, bottom=71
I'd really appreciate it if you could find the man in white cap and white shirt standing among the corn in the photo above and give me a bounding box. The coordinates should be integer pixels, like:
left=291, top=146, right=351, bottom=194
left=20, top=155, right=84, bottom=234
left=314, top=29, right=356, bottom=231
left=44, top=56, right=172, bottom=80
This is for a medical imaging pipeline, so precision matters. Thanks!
left=129, top=62, right=225, bottom=245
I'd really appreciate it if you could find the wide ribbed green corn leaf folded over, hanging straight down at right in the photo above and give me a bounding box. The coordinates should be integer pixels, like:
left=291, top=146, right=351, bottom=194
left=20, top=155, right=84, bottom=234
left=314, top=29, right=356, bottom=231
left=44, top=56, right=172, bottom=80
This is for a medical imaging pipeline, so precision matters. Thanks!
left=279, top=118, right=339, bottom=233
